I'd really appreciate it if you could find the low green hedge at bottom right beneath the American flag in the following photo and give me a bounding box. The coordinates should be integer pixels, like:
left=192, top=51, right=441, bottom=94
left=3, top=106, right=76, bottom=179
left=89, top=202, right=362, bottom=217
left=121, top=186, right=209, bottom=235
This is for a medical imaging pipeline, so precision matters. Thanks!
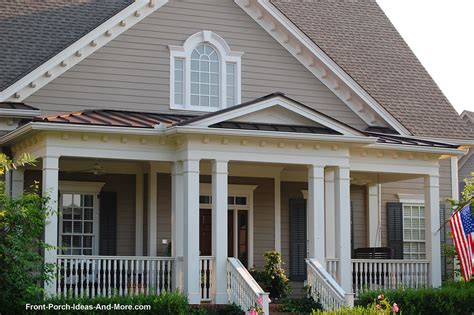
left=357, top=281, right=474, bottom=314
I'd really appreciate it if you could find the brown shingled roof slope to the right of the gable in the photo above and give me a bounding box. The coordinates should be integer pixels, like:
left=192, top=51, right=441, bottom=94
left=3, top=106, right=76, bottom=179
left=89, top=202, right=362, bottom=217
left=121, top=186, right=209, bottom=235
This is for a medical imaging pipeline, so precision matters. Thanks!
left=270, top=0, right=472, bottom=138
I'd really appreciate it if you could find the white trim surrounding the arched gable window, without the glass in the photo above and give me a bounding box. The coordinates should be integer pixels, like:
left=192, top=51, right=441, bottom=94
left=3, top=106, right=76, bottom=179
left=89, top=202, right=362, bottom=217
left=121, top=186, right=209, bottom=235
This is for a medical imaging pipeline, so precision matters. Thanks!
left=168, top=30, right=244, bottom=112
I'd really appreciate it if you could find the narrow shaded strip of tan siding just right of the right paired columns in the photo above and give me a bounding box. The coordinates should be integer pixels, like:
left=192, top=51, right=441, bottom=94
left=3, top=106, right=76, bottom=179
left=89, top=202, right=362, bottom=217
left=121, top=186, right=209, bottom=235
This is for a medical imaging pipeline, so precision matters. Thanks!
left=351, top=185, right=368, bottom=252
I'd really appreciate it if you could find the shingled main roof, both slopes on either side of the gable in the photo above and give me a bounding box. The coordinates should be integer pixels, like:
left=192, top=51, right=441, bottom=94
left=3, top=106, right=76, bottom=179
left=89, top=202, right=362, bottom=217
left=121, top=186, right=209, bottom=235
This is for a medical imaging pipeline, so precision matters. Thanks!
left=0, top=0, right=470, bottom=138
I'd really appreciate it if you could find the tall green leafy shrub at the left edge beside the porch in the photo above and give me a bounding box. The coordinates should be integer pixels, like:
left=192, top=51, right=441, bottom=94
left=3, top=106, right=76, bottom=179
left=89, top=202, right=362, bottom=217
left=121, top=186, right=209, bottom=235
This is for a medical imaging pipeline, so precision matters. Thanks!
left=0, top=154, right=53, bottom=313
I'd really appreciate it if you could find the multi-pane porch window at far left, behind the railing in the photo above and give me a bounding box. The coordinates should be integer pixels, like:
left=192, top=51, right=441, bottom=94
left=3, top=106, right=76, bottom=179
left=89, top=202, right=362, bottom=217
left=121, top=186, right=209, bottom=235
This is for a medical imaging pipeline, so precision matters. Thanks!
left=59, top=181, right=104, bottom=255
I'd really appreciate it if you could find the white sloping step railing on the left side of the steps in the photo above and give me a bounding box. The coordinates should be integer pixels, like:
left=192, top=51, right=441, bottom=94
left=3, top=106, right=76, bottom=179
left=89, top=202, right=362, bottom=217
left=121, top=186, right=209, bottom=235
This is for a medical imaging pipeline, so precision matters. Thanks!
left=227, top=257, right=270, bottom=315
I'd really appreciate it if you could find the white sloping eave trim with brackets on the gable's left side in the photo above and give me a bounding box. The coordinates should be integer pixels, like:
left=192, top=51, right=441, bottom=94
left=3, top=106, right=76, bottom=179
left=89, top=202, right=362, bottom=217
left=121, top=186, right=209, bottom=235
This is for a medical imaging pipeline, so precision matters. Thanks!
left=0, top=0, right=168, bottom=102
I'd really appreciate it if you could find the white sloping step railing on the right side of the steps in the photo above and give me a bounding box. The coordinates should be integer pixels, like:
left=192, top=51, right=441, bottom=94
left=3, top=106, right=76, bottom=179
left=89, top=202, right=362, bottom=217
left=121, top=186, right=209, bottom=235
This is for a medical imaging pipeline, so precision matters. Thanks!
left=306, top=259, right=353, bottom=310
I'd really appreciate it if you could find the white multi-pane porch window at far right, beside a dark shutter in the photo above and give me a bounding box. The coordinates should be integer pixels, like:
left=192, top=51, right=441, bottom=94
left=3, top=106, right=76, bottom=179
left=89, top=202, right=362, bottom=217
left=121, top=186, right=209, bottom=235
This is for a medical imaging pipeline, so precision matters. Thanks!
left=403, top=204, right=426, bottom=259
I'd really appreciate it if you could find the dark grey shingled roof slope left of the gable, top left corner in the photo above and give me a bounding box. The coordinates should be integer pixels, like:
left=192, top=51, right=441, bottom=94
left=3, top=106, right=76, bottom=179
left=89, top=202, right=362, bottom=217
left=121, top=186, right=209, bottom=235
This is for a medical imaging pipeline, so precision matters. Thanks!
left=0, top=0, right=133, bottom=91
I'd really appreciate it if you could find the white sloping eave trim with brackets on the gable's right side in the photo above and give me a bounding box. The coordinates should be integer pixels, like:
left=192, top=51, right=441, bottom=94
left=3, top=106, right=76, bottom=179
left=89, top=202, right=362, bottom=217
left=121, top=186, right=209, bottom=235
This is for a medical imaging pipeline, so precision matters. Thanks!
left=234, top=0, right=411, bottom=135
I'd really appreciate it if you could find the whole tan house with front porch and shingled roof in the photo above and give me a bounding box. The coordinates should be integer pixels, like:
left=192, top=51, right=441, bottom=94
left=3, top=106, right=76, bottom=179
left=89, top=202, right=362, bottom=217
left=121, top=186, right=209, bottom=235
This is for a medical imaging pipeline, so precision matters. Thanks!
left=0, top=0, right=473, bottom=311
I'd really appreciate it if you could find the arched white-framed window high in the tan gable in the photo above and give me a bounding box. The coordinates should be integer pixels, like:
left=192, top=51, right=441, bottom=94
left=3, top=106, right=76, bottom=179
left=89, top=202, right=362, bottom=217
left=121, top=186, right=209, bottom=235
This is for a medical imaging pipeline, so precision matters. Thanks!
left=169, top=31, right=242, bottom=112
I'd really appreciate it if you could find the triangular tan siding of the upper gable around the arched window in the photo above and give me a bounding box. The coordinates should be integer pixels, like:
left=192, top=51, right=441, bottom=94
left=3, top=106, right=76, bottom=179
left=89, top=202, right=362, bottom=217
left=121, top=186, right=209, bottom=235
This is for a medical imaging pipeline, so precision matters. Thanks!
left=26, top=0, right=366, bottom=128
